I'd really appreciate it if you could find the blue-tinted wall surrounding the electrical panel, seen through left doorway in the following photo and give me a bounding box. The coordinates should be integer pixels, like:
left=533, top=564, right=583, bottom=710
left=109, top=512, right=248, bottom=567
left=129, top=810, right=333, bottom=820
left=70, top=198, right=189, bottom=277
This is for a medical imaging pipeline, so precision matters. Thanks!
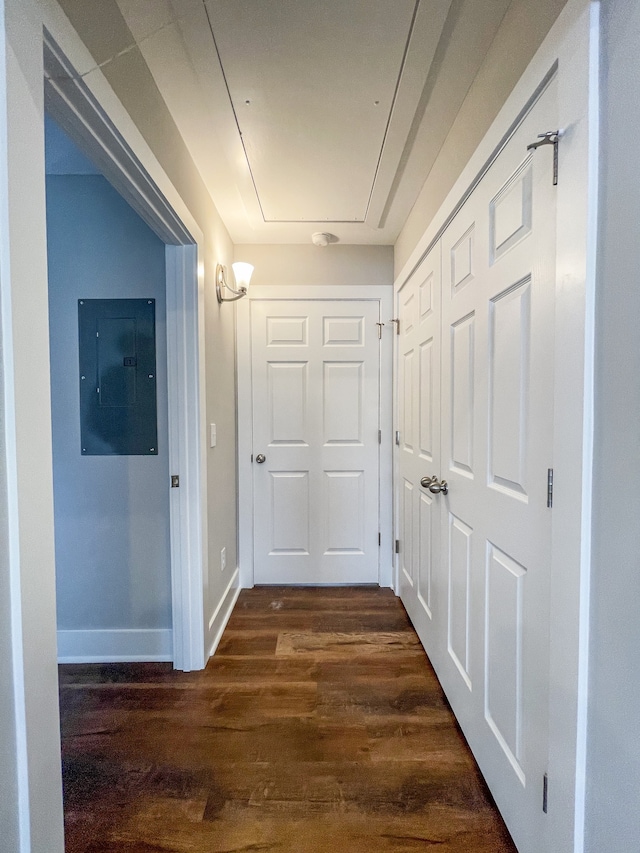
left=47, top=175, right=171, bottom=630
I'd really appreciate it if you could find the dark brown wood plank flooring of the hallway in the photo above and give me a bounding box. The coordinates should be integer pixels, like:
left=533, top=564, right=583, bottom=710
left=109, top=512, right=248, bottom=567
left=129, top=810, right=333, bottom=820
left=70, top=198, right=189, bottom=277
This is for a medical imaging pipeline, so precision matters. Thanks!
left=60, top=587, right=515, bottom=853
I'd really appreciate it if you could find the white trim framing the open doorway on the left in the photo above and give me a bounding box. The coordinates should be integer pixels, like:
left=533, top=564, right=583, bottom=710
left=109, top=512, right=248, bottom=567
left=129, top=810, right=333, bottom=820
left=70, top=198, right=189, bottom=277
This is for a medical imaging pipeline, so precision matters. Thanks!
left=43, top=29, right=208, bottom=671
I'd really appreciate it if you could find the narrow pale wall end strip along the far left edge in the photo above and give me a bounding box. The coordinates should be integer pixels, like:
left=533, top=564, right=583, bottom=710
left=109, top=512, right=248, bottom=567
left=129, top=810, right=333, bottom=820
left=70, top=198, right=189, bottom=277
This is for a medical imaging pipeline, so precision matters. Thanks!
left=0, top=0, right=64, bottom=853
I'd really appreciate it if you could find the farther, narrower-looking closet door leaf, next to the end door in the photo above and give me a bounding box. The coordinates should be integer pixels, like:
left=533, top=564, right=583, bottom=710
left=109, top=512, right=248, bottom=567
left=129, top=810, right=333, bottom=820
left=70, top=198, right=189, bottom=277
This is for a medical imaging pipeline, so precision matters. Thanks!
left=397, top=244, right=442, bottom=656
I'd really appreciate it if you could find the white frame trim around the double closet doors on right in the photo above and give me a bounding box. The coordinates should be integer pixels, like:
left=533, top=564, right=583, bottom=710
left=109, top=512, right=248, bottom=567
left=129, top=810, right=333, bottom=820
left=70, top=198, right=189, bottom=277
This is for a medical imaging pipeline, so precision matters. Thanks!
left=394, top=0, right=600, bottom=853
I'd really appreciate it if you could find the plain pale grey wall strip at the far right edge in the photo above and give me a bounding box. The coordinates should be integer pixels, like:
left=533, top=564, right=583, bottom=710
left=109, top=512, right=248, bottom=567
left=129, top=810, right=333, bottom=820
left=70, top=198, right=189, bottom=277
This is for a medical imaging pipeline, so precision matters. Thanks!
left=586, top=0, right=640, bottom=853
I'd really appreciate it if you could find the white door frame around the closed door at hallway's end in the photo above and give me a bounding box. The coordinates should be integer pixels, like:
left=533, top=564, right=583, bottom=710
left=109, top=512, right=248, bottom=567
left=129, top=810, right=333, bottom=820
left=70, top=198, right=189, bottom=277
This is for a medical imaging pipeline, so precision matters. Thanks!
left=236, top=284, right=394, bottom=589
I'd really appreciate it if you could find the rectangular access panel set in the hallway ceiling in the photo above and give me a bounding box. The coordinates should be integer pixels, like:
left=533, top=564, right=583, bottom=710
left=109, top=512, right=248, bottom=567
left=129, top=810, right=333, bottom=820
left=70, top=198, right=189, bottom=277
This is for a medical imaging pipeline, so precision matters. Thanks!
left=202, top=0, right=417, bottom=222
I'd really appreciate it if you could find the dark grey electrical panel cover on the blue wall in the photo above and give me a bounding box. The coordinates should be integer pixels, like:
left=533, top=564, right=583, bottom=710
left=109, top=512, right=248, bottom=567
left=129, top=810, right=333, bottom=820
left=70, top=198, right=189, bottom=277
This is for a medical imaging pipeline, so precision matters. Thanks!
left=78, top=299, right=158, bottom=456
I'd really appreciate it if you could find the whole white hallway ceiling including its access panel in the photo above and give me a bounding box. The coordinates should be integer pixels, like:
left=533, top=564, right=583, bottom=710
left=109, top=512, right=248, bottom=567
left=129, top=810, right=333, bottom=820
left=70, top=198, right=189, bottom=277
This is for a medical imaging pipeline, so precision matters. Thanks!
left=117, top=0, right=509, bottom=244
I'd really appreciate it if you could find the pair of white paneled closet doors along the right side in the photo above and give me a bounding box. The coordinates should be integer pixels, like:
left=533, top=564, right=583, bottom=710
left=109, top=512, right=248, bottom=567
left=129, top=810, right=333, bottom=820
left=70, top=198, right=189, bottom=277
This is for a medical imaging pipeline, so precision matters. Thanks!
left=397, top=76, right=557, bottom=853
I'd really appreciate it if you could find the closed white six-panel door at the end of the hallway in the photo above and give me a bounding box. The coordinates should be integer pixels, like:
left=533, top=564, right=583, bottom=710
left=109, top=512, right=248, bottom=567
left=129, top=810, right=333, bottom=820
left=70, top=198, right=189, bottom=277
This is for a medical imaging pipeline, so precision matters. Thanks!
left=251, top=300, right=380, bottom=584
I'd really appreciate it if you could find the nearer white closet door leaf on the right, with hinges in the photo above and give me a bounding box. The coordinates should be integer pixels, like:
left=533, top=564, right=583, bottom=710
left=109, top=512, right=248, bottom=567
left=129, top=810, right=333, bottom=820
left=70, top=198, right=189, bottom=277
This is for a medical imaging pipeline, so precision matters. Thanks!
left=439, top=84, right=557, bottom=853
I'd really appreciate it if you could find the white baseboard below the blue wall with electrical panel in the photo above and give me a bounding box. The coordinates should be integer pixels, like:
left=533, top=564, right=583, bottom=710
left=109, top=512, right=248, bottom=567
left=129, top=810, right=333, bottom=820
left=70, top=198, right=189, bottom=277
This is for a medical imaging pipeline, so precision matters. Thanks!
left=58, top=628, right=173, bottom=663
